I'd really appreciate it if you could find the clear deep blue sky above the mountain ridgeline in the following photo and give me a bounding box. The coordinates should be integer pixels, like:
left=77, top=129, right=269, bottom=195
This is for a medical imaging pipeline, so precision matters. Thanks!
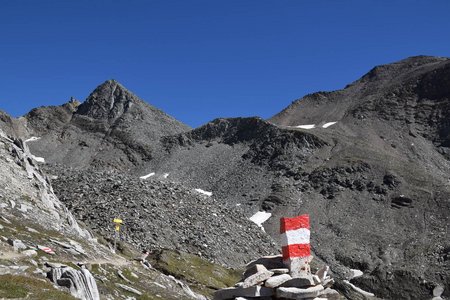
left=0, top=0, right=450, bottom=127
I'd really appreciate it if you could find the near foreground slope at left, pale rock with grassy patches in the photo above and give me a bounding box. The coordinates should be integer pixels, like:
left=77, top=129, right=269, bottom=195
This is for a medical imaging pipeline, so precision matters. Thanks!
left=0, top=130, right=238, bottom=300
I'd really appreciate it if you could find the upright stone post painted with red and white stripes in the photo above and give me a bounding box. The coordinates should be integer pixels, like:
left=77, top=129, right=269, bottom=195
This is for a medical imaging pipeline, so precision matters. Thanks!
left=280, top=215, right=312, bottom=278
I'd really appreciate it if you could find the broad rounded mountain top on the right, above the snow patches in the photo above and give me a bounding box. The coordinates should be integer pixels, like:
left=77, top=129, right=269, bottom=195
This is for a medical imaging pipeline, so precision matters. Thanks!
left=269, top=56, right=450, bottom=151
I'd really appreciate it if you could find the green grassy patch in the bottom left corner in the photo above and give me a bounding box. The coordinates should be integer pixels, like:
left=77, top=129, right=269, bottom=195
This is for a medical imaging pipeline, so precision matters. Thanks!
left=0, top=275, right=75, bottom=300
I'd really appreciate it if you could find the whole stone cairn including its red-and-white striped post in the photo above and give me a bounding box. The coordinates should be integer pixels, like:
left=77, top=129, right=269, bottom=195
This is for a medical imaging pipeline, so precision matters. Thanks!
left=214, top=215, right=340, bottom=300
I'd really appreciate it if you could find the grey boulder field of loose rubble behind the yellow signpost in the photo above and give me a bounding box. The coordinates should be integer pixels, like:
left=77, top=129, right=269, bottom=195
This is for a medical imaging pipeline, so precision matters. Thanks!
left=49, top=166, right=279, bottom=267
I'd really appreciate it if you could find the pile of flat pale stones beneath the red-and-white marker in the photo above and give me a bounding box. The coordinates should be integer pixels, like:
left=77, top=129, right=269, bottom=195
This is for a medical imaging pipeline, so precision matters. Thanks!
left=214, top=255, right=340, bottom=300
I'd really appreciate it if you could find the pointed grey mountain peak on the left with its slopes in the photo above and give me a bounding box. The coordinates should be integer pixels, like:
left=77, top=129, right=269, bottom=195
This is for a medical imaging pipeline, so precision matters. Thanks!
left=23, top=80, right=189, bottom=170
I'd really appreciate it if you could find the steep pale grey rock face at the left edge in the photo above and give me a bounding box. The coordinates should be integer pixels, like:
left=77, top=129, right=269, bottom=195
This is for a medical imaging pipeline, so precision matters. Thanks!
left=0, top=130, right=91, bottom=239
